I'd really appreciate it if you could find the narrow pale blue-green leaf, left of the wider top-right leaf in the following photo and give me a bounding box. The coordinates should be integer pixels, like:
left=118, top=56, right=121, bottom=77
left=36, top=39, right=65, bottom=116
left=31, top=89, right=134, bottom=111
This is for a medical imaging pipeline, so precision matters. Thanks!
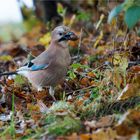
left=108, top=4, right=123, bottom=23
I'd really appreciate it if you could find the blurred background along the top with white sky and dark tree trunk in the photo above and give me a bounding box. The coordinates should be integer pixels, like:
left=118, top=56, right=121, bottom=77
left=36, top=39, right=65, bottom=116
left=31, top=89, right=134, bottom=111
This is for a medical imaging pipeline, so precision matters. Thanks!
left=0, top=0, right=122, bottom=41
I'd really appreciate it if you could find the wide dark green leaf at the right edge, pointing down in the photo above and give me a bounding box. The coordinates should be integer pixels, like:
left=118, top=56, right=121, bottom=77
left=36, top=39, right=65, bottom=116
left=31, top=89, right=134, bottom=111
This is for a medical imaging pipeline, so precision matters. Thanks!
left=125, top=6, right=140, bottom=29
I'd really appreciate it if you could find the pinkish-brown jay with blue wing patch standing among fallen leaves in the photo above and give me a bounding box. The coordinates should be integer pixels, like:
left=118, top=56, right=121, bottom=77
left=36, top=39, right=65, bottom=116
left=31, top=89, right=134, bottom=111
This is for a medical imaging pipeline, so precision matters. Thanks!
left=0, top=25, right=78, bottom=100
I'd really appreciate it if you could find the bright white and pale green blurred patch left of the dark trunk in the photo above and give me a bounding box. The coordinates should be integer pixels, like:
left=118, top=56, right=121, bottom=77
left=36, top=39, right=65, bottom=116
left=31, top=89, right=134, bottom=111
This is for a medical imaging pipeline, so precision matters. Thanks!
left=0, top=0, right=33, bottom=41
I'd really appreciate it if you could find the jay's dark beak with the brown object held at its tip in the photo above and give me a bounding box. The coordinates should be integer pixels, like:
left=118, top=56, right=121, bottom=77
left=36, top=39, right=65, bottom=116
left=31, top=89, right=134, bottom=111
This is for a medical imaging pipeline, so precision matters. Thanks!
left=59, top=32, right=78, bottom=42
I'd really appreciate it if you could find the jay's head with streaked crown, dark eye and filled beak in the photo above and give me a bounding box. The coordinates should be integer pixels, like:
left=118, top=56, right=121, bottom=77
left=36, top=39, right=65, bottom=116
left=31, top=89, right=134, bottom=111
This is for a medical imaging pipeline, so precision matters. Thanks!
left=52, top=26, right=78, bottom=43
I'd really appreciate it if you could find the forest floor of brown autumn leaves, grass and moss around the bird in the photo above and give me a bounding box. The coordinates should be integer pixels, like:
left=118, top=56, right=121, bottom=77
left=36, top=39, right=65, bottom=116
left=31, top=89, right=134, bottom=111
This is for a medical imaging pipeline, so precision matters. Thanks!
left=0, top=3, right=140, bottom=140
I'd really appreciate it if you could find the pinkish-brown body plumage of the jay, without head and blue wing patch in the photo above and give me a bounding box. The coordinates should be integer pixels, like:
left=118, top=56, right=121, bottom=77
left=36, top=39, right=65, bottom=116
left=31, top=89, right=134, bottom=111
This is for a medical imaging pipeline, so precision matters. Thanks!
left=28, top=38, right=71, bottom=88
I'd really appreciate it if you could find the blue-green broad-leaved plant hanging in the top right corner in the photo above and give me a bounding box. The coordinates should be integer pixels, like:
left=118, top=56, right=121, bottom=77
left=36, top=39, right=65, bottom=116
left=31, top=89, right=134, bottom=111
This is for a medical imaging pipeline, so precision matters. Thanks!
left=108, top=0, right=140, bottom=29
